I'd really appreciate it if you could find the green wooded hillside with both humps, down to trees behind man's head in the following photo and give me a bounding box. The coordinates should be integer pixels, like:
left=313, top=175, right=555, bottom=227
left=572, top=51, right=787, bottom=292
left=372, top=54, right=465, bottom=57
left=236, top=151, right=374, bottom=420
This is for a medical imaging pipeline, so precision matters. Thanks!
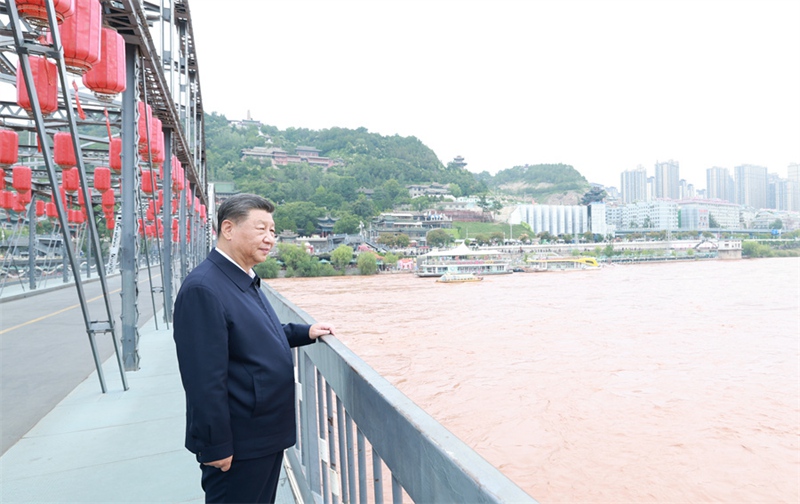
left=204, top=113, right=588, bottom=233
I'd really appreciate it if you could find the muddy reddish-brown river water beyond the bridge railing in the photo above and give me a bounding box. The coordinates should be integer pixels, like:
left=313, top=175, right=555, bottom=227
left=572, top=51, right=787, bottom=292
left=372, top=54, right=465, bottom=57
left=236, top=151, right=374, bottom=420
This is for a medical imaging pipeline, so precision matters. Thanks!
left=269, top=258, right=800, bottom=503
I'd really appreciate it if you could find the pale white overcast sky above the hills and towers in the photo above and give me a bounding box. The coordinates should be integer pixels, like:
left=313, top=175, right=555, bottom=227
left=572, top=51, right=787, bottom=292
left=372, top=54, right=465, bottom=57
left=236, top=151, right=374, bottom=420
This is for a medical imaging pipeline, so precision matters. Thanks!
left=184, top=0, right=800, bottom=188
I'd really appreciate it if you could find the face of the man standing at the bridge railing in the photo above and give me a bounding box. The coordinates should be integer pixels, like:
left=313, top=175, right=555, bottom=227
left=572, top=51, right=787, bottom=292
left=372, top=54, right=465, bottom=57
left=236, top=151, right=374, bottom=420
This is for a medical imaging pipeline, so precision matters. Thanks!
left=225, top=210, right=277, bottom=270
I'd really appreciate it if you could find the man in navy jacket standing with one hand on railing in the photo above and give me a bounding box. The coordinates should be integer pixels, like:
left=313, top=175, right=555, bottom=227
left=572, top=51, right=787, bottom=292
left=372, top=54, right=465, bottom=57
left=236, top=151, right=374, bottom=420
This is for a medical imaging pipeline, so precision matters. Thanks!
left=173, top=194, right=334, bottom=503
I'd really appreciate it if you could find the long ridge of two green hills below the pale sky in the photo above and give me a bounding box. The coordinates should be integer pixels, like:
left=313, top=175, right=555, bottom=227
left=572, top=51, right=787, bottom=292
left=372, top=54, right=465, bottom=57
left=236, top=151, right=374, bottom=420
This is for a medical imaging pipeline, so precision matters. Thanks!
left=205, top=113, right=589, bottom=210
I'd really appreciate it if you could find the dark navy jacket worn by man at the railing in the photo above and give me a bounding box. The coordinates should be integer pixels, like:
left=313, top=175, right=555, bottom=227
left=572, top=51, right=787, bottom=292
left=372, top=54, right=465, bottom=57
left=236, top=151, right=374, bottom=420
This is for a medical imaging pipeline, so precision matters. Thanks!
left=173, top=250, right=314, bottom=462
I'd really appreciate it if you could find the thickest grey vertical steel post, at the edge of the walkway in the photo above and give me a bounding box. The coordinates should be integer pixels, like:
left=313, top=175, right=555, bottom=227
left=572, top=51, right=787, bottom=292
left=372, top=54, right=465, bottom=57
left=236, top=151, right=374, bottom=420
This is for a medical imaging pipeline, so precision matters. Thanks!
left=120, top=43, right=139, bottom=371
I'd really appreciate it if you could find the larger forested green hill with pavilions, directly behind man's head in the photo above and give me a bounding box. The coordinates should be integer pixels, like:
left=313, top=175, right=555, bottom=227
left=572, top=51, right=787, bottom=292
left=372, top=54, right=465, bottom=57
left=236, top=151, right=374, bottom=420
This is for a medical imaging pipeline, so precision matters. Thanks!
left=205, top=113, right=486, bottom=203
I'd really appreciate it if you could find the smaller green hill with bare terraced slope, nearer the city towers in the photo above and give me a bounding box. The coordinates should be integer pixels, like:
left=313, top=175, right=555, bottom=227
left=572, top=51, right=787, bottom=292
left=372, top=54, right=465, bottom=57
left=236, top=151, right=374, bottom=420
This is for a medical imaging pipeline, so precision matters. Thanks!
left=476, top=164, right=589, bottom=200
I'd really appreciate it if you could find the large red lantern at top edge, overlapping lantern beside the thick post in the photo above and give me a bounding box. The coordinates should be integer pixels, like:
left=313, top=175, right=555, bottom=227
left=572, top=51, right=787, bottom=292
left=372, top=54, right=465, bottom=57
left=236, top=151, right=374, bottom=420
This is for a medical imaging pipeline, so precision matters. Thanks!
left=61, top=0, right=103, bottom=75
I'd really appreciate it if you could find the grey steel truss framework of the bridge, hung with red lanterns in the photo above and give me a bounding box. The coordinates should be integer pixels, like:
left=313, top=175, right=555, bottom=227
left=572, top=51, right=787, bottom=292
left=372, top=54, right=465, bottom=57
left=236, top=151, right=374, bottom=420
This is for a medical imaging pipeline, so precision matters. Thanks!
left=0, top=0, right=213, bottom=393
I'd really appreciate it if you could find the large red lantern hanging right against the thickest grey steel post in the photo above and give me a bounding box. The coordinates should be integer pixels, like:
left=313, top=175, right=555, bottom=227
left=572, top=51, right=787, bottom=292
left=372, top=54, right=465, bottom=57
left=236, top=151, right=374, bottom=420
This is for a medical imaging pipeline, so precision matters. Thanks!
left=83, top=28, right=126, bottom=103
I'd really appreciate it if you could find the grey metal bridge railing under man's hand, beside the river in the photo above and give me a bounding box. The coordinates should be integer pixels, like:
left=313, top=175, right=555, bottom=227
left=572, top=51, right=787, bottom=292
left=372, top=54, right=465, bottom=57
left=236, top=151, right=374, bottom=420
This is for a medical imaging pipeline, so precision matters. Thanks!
left=264, top=286, right=536, bottom=504
